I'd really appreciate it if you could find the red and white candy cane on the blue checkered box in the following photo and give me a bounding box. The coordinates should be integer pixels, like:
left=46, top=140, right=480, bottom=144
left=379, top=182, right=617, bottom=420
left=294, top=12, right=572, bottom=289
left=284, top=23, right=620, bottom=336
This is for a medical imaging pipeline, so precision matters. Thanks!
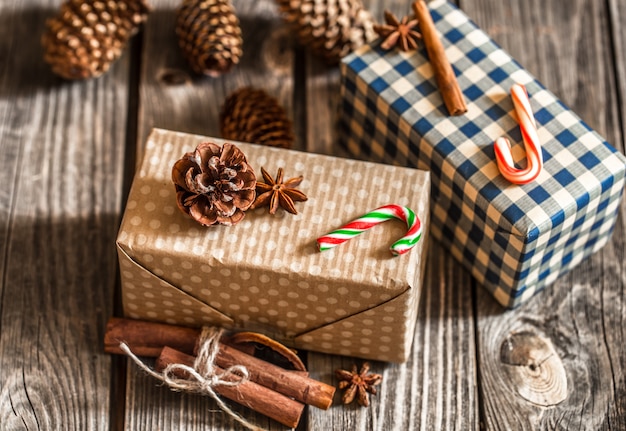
left=494, top=84, right=543, bottom=184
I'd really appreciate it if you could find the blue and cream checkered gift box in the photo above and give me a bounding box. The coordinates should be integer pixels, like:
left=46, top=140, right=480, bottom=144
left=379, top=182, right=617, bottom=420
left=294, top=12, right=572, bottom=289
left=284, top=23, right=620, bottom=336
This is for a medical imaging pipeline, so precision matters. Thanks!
left=340, top=1, right=626, bottom=307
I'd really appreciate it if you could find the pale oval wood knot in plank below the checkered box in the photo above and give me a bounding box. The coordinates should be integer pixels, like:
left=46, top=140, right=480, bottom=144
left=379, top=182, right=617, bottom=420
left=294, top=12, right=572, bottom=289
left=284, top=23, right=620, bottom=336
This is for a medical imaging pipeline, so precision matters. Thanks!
left=500, top=331, right=567, bottom=407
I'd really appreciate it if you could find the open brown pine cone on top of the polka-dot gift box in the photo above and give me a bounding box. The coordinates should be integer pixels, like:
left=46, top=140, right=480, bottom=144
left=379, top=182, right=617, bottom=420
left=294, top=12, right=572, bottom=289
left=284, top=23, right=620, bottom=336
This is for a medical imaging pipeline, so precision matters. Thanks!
left=172, top=142, right=256, bottom=226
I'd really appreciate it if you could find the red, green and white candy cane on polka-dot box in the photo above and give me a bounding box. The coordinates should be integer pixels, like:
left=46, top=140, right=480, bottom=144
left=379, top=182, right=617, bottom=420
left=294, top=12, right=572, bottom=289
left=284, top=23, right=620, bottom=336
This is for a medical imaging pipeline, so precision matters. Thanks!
left=317, top=204, right=422, bottom=256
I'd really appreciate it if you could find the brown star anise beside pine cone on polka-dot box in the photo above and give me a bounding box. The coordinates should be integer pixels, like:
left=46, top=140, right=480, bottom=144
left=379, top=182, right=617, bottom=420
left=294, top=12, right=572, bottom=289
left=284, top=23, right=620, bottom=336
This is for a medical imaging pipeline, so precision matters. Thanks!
left=252, top=168, right=307, bottom=214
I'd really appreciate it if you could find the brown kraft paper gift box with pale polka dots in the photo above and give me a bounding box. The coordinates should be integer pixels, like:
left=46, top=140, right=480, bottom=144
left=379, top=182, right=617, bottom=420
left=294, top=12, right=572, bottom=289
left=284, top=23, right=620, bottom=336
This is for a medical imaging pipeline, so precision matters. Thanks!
left=117, top=130, right=430, bottom=362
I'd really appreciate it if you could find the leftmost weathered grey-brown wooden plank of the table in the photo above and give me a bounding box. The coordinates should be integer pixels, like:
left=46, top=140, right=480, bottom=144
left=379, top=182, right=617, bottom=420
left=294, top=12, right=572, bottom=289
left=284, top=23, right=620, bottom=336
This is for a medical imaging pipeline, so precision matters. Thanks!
left=0, top=0, right=128, bottom=430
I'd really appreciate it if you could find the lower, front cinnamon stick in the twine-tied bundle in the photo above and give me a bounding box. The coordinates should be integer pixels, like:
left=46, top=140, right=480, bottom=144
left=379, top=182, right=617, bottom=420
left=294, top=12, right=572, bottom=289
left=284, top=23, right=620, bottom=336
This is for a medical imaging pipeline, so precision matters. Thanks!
left=155, top=346, right=304, bottom=428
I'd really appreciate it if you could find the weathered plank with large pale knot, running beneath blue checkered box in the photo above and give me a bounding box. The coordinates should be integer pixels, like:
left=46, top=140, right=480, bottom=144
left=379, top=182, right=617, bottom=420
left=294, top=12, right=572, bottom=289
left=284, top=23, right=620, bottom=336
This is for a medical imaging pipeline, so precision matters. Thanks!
left=463, top=0, right=626, bottom=430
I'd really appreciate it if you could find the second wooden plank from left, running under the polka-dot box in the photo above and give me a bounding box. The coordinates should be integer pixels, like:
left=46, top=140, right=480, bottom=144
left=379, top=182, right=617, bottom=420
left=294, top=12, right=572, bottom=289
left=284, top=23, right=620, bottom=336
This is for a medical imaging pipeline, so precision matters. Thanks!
left=124, top=0, right=299, bottom=431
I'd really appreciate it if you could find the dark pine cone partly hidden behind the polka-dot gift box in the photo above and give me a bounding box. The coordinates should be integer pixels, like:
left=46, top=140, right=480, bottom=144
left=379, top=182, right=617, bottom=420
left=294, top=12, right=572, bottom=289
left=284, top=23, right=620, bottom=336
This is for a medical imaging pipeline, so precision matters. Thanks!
left=220, top=87, right=294, bottom=148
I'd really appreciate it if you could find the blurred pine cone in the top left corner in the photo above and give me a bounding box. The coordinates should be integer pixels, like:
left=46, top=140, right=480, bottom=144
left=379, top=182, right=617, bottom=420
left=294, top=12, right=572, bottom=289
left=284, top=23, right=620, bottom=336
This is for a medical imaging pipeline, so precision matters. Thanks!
left=41, top=0, right=149, bottom=79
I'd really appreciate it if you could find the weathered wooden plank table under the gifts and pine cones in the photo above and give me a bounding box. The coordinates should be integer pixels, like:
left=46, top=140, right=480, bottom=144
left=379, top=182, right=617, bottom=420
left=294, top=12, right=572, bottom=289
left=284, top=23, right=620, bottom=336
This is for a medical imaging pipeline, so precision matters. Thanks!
left=0, top=0, right=626, bottom=431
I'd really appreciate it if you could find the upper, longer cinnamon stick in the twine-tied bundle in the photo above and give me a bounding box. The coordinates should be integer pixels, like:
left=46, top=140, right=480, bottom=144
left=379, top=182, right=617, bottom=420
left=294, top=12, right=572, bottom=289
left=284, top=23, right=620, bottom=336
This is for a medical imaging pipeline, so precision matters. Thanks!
left=104, top=318, right=335, bottom=410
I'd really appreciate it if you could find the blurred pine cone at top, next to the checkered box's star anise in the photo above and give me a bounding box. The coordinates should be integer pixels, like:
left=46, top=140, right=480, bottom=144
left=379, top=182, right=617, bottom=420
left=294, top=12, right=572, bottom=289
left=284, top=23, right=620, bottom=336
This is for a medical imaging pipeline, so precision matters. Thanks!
left=276, top=0, right=377, bottom=64
